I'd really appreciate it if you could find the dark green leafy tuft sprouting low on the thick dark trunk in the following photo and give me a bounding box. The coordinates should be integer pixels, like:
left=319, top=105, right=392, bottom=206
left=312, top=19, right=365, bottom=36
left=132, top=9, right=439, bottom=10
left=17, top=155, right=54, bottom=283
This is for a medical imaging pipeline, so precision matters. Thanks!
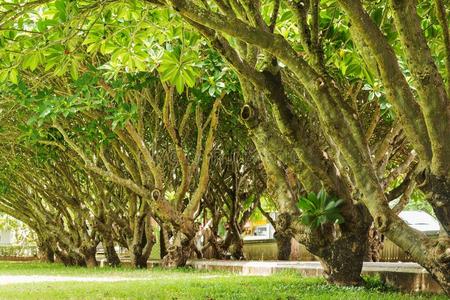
left=297, top=189, right=344, bottom=228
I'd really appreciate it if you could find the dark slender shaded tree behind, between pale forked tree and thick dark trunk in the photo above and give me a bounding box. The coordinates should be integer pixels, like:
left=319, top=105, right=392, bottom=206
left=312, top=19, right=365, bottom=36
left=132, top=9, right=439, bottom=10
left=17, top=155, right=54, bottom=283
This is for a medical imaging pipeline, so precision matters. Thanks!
left=203, top=120, right=265, bottom=259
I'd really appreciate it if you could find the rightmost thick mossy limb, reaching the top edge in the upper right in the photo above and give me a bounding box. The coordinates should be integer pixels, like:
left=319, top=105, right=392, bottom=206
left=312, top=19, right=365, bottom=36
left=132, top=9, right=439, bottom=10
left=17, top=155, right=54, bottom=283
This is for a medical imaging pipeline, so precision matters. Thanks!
left=390, top=0, right=450, bottom=176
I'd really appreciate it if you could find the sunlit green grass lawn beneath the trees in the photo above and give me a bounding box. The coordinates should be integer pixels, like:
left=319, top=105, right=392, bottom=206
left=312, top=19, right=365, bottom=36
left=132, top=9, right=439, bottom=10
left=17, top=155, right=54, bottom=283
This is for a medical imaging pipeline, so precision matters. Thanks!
left=0, top=261, right=447, bottom=300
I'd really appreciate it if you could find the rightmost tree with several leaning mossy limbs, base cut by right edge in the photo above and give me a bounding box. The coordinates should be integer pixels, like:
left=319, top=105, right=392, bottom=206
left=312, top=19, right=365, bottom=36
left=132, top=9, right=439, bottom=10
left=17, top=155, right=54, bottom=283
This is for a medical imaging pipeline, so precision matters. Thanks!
left=146, top=0, right=450, bottom=292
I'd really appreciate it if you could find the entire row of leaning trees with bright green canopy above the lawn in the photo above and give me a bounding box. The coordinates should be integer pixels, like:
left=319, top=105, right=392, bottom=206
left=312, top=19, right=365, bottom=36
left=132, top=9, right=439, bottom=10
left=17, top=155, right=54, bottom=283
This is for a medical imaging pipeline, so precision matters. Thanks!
left=0, top=0, right=450, bottom=293
